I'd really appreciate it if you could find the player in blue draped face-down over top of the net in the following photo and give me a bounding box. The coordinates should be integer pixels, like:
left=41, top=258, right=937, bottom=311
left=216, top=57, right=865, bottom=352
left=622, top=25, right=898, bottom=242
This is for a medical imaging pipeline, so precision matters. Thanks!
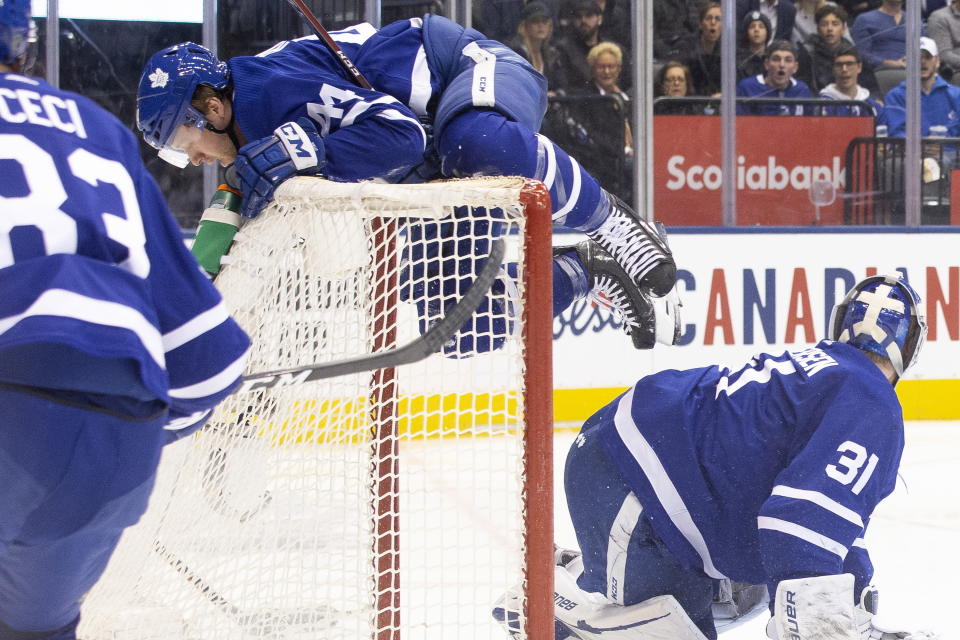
left=138, top=15, right=679, bottom=353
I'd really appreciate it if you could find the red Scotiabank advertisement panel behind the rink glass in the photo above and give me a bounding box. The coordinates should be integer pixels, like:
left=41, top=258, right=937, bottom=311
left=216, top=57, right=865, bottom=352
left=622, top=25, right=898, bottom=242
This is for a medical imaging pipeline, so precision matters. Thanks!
left=653, top=116, right=873, bottom=226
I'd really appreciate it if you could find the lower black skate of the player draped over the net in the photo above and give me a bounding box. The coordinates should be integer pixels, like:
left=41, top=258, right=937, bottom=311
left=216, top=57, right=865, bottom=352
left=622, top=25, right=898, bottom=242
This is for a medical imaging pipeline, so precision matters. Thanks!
left=553, top=240, right=660, bottom=349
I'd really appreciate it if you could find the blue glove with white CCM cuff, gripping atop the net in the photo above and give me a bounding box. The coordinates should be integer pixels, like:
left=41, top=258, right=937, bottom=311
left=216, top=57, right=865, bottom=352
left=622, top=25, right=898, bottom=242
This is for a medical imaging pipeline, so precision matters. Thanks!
left=233, top=118, right=327, bottom=218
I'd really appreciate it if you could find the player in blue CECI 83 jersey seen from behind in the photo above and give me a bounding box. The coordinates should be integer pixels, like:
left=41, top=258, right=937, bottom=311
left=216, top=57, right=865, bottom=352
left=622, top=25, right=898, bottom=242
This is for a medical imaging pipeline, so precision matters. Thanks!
left=0, top=0, right=249, bottom=640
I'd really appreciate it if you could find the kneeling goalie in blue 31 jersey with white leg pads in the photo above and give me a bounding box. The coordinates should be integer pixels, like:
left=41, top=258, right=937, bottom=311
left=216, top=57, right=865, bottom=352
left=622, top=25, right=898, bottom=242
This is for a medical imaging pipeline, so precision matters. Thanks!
left=494, top=275, right=935, bottom=640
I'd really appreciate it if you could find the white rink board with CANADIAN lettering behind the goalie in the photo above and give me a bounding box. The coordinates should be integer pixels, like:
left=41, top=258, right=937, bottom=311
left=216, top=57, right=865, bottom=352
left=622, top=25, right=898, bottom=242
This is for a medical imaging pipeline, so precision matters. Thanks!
left=554, top=229, right=960, bottom=419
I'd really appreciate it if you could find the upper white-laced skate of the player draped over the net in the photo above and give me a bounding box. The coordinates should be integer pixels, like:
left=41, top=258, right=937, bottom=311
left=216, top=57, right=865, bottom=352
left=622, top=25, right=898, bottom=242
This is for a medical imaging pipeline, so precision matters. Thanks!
left=587, top=193, right=677, bottom=298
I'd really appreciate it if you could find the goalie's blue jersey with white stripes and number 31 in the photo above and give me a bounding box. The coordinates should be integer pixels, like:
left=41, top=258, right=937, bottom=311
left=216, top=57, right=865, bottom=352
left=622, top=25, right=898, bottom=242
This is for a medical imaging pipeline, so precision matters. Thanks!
left=594, top=340, right=904, bottom=590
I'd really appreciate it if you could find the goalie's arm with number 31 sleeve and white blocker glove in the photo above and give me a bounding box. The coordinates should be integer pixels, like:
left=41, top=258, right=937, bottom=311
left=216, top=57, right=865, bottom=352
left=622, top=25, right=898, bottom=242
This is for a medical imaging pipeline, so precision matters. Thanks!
left=758, top=378, right=925, bottom=640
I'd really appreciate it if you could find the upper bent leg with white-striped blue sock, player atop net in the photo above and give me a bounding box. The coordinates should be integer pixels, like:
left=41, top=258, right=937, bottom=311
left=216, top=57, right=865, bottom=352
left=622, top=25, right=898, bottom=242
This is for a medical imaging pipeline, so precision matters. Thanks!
left=436, top=110, right=610, bottom=232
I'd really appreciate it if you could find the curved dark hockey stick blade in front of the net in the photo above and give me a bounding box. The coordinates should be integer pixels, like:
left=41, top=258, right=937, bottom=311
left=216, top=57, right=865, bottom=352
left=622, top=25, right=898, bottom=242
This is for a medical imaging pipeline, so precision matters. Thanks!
left=235, top=238, right=506, bottom=393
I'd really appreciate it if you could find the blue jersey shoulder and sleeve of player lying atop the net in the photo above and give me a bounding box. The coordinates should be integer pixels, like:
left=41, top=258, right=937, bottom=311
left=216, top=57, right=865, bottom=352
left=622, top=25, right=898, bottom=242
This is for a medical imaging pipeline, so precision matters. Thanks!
left=227, top=36, right=426, bottom=182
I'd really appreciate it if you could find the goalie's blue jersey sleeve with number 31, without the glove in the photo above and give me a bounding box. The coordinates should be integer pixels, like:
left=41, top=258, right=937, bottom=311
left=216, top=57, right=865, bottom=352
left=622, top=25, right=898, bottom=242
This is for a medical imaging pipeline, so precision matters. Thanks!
left=757, top=378, right=903, bottom=588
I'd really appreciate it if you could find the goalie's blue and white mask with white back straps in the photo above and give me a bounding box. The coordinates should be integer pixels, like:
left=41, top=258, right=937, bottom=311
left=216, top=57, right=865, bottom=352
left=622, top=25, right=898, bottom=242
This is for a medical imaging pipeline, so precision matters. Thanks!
left=829, top=273, right=927, bottom=376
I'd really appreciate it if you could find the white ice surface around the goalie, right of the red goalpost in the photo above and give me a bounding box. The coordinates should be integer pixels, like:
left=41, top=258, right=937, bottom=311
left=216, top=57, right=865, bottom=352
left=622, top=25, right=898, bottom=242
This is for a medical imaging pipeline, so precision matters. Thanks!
left=554, top=421, right=960, bottom=640
